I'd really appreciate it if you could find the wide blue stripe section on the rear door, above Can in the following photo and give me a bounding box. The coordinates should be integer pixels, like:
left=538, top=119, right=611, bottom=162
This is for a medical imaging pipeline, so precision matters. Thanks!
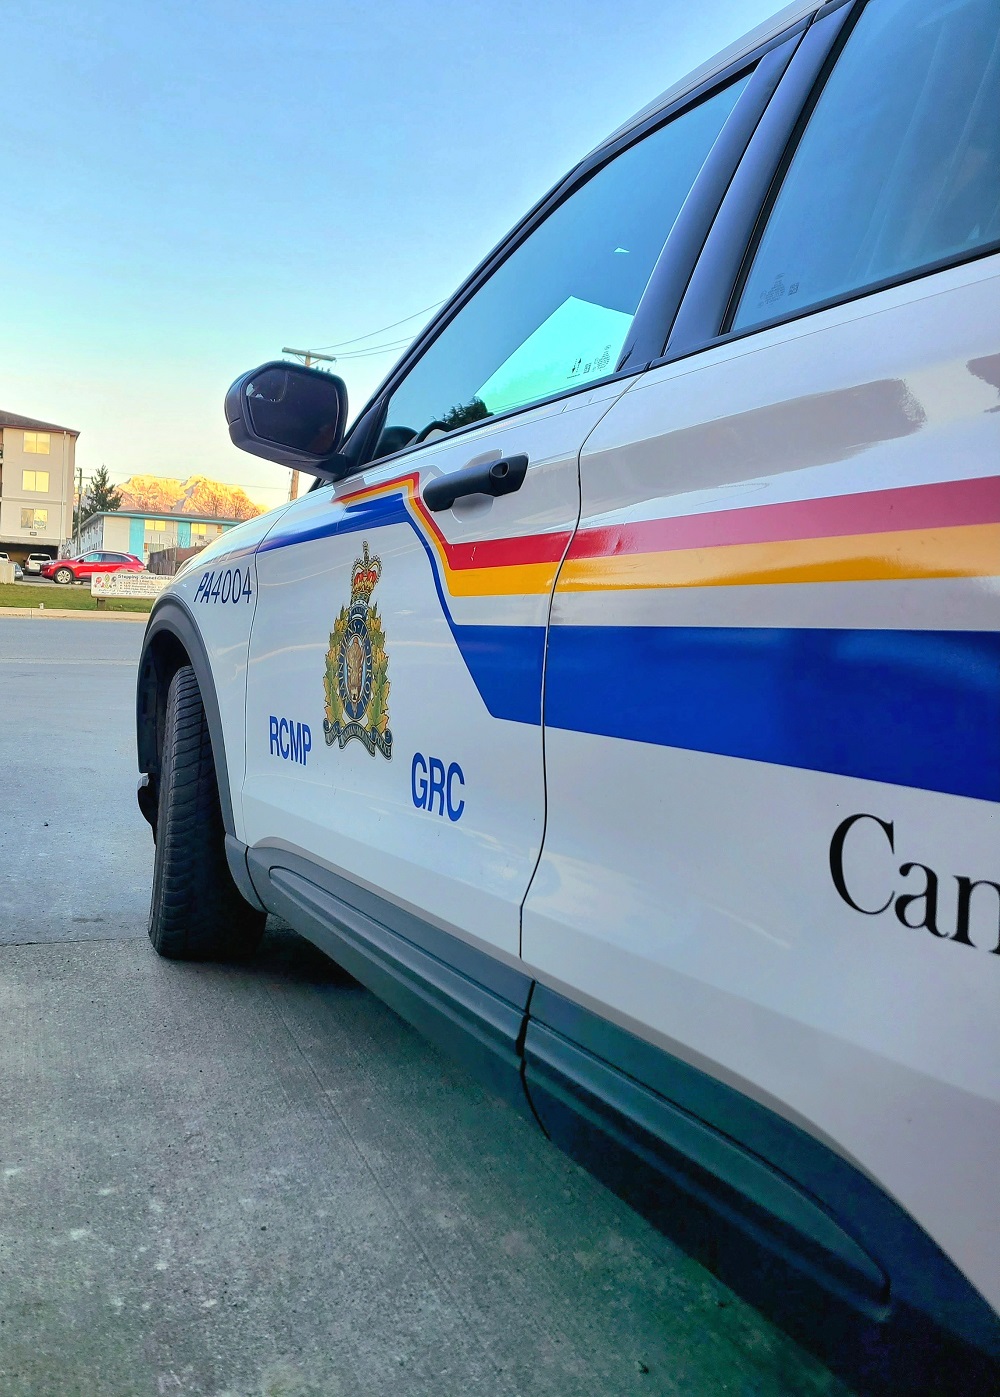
left=545, top=626, right=1000, bottom=800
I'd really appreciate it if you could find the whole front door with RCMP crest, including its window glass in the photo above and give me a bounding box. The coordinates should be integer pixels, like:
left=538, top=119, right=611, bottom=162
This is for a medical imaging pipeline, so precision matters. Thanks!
left=243, top=80, right=744, bottom=957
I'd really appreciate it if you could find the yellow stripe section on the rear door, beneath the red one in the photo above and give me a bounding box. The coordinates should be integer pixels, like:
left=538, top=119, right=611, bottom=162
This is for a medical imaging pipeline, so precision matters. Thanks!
left=559, top=524, right=1000, bottom=591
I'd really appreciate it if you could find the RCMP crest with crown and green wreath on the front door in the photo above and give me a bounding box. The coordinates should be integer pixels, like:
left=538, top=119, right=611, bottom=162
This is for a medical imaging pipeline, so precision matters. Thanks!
left=323, top=539, right=392, bottom=760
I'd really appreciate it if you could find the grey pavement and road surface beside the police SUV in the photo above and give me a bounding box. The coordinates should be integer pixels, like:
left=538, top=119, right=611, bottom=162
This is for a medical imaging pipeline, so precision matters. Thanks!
left=0, top=619, right=845, bottom=1397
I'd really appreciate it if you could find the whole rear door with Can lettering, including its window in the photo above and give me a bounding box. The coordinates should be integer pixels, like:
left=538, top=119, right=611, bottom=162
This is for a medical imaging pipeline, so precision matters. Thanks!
left=524, top=0, right=1000, bottom=1305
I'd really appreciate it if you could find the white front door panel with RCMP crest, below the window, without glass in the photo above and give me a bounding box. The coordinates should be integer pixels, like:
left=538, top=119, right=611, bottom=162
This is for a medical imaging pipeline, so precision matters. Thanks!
left=243, top=386, right=619, bottom=956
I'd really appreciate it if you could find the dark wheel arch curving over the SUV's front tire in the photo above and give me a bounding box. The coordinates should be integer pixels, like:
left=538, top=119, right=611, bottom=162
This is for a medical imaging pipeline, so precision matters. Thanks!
left=135, top=595, right=236, bottom=835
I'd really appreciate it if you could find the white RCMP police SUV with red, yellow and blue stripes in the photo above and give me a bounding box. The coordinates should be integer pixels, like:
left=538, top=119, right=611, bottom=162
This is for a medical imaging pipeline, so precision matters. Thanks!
left=138, top=0, right=1000, bottom=1391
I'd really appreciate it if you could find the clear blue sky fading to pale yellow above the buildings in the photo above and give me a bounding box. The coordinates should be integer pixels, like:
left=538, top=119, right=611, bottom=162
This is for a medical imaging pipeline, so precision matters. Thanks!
left=0, top=0, right=777, bottom=504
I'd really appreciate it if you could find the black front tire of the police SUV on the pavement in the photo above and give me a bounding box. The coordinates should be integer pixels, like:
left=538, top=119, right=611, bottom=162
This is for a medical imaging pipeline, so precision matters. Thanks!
left=149, top=665, right=265, bottom=960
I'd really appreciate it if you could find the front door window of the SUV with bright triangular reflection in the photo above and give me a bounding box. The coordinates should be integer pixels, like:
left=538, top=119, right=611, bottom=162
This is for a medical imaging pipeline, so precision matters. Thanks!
left=376, top=78, right=747, bottom=457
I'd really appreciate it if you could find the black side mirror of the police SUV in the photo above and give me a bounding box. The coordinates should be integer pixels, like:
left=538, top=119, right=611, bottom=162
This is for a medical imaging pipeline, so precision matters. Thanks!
left=226, top=359, right=351, bottom=481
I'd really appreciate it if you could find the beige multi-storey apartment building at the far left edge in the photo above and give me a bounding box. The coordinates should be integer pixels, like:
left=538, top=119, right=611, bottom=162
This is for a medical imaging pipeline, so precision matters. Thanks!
left=0, top=411, right=80, bottom=562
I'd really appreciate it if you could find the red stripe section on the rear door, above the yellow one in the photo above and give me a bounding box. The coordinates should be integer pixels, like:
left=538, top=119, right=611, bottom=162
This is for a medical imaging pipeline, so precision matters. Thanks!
left=570, top=475, right=1000, bottom=557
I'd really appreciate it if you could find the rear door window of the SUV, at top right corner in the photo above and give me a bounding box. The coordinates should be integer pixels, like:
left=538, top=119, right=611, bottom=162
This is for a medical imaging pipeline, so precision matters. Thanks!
left=733, top=0, right=1000, bottom=330
